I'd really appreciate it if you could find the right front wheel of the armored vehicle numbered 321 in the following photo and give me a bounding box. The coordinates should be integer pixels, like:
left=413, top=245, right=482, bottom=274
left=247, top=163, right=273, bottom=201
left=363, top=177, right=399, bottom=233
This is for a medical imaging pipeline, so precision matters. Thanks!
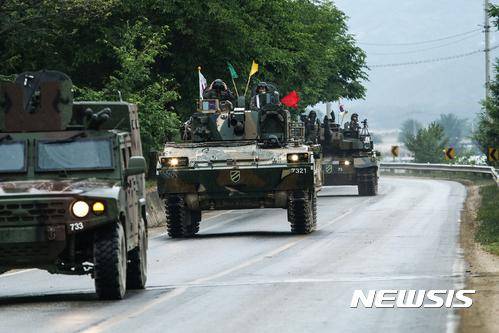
left=288, top=191, right=317, bottom=234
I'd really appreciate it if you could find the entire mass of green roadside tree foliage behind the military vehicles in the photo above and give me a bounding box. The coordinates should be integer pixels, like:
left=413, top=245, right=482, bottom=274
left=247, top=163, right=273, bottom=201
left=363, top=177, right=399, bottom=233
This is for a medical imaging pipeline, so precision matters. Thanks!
left=0, top=0, right=366, bottom=146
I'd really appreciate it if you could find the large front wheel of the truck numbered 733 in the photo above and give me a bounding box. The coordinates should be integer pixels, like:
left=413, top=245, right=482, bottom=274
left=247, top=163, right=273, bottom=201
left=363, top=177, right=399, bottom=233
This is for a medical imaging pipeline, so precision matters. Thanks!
left=94, top=223, right=127, bottom=300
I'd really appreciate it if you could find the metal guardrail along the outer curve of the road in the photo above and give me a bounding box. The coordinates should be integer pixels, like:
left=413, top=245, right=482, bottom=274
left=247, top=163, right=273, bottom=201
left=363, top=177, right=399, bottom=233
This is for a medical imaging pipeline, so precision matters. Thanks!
left=380, top=162, right=499, bottom=186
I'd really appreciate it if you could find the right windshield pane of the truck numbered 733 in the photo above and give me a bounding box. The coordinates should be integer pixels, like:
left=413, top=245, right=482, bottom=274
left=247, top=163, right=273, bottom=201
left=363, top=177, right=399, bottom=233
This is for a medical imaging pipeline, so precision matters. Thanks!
left=36, top=139, right=114, bottom=171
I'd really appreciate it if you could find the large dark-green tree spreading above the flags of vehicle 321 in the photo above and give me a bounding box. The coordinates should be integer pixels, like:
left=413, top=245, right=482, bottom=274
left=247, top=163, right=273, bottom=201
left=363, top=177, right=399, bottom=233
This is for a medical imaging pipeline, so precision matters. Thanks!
left=141, top=0, right=366, bottom=114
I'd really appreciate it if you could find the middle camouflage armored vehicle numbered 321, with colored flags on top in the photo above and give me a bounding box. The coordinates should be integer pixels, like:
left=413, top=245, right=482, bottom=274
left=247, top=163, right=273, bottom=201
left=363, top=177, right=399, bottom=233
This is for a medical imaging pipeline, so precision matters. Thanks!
left=157, top=90, right=320, bottom=238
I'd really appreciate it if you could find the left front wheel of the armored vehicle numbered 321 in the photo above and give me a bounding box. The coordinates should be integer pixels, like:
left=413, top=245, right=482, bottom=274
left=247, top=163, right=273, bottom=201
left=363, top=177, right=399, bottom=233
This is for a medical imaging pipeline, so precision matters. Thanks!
left=165, top=196, right=201, bottom=238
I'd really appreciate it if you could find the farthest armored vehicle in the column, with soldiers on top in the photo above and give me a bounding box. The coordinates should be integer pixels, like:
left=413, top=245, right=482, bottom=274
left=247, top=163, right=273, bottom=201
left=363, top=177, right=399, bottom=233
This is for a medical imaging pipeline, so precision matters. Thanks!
left=306, top=114, right=379, bottom=196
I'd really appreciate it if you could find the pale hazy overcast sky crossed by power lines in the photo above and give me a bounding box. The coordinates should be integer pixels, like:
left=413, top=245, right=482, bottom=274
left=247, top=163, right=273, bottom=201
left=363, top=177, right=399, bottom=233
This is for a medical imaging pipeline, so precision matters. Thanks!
left=318, top=0, right=499, bottom=129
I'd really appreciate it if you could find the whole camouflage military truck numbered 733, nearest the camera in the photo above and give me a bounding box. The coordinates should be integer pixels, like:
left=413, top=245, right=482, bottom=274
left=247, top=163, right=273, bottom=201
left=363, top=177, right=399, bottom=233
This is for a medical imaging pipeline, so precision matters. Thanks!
left=0, top=71, right=147, bottom=299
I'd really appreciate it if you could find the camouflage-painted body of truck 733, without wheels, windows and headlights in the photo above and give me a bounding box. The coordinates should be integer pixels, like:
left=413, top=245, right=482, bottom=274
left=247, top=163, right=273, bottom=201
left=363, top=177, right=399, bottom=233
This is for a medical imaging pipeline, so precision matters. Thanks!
left=0, top=71, right=147, bottom=280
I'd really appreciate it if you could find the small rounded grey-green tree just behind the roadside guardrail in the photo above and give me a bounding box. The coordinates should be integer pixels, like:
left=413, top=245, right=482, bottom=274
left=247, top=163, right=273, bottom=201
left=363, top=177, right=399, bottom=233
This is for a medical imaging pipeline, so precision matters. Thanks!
left=406, top=122, right=447, bottom=163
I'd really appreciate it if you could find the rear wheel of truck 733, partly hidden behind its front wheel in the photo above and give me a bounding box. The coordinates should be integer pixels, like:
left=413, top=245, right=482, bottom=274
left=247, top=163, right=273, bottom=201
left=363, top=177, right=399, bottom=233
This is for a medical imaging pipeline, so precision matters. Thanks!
left=126, top=219, right=148, bottom=289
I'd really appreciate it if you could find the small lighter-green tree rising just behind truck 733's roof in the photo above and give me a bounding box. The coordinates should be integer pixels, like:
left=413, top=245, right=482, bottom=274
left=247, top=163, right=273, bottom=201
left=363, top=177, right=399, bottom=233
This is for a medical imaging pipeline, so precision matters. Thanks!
left=79, top=19, right=180, bottom=154
